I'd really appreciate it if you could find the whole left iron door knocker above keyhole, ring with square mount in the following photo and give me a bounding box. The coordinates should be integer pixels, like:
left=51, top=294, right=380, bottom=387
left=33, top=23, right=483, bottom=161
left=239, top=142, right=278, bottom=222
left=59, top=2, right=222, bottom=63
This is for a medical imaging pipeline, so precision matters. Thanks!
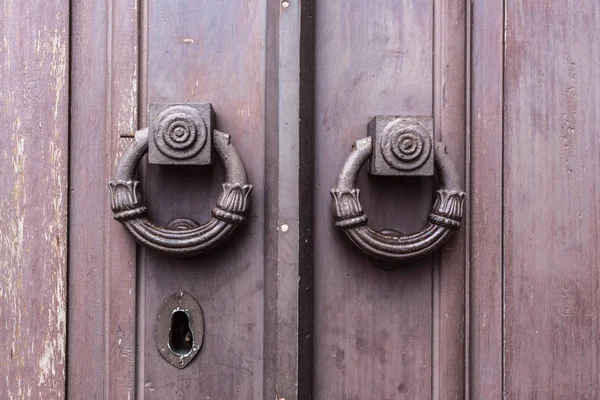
left=109, top=103, right=252, bottom=256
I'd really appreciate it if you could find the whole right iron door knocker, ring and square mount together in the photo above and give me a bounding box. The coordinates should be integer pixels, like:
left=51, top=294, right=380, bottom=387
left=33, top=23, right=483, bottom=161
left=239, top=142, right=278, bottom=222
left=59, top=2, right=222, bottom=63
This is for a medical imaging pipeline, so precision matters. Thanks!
left=331, top=117, right=465, bottom=269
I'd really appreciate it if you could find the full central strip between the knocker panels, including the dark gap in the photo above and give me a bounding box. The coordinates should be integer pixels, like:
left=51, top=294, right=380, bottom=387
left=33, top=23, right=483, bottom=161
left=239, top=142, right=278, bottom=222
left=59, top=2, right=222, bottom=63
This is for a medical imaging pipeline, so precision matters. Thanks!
left=265, top=0, right=314, bottom=400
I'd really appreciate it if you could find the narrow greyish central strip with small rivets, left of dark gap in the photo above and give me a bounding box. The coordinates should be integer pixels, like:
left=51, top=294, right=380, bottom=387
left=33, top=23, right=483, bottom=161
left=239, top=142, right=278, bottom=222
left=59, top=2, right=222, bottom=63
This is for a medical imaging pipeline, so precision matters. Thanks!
left=274, top=1, right=301, bottom=400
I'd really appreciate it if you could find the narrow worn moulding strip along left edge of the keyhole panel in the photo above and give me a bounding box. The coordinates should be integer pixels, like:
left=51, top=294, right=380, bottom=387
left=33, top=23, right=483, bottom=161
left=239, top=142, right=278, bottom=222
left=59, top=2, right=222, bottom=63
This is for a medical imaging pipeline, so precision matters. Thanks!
left=104, top=0, right=143, bottom=400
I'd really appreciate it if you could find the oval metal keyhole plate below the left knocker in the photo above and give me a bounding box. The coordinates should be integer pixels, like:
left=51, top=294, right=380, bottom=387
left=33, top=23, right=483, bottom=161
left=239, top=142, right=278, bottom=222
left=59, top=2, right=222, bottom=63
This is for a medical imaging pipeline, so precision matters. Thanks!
left=154, top=291, right=204, bottom=369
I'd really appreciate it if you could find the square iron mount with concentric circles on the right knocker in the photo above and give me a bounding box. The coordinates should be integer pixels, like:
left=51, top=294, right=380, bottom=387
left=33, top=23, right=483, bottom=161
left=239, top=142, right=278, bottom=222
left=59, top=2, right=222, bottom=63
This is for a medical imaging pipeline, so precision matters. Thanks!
left=368, top=116, right=434, bottom=176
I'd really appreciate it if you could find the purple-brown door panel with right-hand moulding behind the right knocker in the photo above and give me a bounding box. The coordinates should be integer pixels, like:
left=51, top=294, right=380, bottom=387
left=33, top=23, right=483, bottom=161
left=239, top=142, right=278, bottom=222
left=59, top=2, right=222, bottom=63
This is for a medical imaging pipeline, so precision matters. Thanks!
left=314, top=0, right=466, bottom=399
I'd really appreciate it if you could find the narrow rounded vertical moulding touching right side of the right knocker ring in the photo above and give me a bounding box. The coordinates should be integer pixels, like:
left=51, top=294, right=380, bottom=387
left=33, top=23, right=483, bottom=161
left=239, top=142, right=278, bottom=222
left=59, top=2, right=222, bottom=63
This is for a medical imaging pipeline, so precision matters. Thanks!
left=432, top=0, right=469, bottom=400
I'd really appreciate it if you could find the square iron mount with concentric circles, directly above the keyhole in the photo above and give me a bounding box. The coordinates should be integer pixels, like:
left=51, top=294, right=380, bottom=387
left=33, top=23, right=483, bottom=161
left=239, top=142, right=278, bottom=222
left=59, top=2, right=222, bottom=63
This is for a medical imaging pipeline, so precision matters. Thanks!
left=148, top=103, right=214, bottom=165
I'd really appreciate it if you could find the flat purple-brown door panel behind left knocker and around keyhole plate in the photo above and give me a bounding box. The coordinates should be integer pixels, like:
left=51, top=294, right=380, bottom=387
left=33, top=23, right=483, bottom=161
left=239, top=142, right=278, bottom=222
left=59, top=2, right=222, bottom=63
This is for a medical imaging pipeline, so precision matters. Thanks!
left=138, top=0, right=274, bottom=399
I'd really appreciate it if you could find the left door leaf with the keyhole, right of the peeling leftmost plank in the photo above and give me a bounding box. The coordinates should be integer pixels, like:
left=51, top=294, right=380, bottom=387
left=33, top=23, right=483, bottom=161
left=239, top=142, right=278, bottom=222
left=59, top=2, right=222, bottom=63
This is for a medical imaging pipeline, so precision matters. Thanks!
left=68, top=0, right=312, bottom=399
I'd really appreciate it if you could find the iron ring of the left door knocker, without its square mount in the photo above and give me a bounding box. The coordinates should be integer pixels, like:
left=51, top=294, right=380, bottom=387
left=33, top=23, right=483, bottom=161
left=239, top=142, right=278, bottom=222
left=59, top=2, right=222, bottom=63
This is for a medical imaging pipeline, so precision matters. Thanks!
left=109, top=128, right=252, bottom=256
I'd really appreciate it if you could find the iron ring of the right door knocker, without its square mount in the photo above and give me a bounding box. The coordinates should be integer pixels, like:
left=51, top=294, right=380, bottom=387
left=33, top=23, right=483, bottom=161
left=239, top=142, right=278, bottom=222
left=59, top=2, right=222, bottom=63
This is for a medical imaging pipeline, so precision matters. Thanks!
left=331, top=137, right=465, bottom=262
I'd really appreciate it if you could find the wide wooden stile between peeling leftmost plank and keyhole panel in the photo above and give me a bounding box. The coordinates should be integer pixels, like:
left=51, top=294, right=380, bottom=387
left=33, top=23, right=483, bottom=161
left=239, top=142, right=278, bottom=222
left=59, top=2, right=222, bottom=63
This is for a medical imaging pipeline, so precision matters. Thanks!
left=68, top=0, right=138, bottom=399
